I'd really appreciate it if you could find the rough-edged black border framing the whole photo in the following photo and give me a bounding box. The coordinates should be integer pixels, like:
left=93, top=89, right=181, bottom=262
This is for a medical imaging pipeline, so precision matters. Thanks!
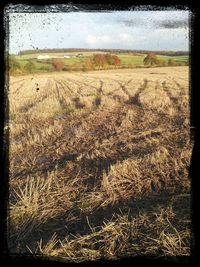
left=0, top=0, right=200, bottom=266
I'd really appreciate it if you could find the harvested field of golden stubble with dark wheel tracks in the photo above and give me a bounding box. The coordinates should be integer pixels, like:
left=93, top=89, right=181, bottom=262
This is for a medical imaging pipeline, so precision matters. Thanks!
left=7, top=67, right=192, bottom=262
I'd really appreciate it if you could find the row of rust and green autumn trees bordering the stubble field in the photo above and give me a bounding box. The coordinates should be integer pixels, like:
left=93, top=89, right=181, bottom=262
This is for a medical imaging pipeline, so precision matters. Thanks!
left=7, top=53, right=188, bottom=74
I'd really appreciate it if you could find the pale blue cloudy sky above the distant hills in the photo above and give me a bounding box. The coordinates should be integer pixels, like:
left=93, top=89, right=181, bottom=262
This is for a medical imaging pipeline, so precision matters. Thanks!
left=9, top=10, right=189, bottom=53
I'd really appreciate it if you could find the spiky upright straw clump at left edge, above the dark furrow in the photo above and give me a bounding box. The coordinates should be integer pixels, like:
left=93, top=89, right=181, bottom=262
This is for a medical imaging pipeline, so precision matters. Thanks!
left=9, top=170, right=76, bottom=242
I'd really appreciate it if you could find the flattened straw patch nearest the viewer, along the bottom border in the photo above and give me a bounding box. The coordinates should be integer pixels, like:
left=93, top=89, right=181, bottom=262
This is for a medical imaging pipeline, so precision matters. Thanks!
left=36, top=202, right=190, bottom=263
